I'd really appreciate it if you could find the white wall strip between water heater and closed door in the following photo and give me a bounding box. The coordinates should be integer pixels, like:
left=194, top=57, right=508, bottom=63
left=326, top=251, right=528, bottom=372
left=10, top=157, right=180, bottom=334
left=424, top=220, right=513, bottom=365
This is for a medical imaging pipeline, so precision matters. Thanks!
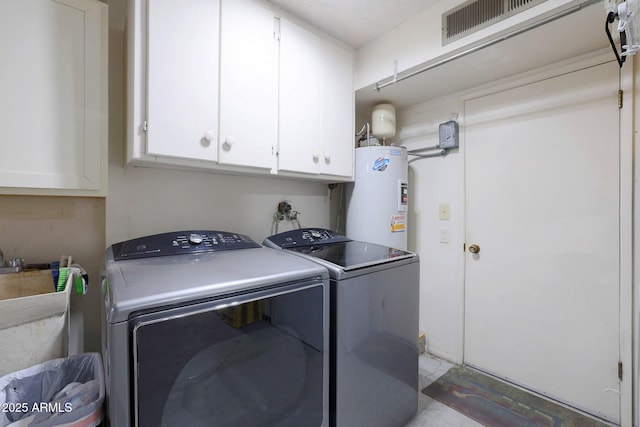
left=395, top=96, right=464, bottom=362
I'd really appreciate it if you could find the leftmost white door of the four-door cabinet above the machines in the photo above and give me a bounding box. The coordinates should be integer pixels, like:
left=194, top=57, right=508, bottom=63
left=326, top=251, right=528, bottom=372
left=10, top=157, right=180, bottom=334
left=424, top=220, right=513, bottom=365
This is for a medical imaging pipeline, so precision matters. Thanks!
left=146, top=0, right=220, bottom=161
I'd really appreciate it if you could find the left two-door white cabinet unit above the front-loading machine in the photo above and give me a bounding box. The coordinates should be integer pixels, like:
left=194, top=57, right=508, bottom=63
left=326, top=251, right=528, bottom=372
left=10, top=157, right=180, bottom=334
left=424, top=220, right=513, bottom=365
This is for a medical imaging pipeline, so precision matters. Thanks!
left=127, top=0, right=277, bottom=173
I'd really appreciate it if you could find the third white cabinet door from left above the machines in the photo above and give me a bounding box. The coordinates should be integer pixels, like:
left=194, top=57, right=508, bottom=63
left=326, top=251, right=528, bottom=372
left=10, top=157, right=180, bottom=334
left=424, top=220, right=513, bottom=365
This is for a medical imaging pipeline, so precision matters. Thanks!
left=278, top=18, right=326, bottom=174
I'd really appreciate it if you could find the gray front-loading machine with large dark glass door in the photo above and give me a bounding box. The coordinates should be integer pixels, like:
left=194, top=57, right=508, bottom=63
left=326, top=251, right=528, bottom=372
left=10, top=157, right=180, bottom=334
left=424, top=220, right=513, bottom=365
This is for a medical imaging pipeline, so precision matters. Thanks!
left=102, top=230, right=329, bottom=427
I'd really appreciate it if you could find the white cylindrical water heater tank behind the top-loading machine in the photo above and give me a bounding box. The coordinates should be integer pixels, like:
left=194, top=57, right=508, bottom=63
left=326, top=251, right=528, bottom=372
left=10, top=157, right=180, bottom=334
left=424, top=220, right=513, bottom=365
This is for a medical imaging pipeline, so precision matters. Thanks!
left=346, top=146, right=409, bottom=250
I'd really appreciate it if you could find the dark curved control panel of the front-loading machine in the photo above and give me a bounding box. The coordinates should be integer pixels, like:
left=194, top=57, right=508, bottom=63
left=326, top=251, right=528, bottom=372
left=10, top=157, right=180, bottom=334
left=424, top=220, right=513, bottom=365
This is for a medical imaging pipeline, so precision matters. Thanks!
left=112, top=230, right=260, bottom=261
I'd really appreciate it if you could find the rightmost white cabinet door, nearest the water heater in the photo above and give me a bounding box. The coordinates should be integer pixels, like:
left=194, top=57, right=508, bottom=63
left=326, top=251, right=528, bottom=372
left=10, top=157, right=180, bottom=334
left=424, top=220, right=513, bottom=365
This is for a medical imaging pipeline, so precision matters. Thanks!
left=320, top=42, right=355, bottom=177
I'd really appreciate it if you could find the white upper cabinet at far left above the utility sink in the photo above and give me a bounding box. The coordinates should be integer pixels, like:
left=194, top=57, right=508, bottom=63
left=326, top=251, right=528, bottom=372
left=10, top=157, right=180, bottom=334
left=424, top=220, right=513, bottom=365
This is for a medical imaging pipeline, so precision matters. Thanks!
left=0, top=0, right=108, bottom=196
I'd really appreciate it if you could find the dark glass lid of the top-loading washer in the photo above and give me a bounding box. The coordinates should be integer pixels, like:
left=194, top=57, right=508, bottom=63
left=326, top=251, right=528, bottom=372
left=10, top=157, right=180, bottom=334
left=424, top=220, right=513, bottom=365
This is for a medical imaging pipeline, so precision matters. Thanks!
left=287, top=240, right=416, bottom=271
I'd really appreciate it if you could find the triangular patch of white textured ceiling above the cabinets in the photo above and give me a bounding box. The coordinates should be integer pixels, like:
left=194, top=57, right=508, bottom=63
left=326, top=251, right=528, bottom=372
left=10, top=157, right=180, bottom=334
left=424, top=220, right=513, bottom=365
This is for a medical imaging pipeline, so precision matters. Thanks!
left=268, top=0, right=437, bottom=48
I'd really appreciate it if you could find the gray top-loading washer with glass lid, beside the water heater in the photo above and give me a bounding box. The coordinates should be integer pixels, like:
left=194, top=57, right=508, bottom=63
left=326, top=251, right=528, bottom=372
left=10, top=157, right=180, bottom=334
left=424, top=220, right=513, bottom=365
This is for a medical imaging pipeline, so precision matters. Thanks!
left=263, top=228, right=420, bottom=427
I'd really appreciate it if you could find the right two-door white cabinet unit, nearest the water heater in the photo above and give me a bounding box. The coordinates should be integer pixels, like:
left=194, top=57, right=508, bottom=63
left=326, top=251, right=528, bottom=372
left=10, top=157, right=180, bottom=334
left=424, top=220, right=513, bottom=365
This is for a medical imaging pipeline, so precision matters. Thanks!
left=278, top=18, right=355, bottom=180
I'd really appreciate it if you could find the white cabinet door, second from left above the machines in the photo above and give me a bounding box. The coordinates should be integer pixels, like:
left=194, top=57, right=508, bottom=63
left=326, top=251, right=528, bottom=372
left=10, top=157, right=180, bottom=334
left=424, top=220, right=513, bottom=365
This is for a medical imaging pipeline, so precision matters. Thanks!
left=219, top=0, right=278, bottom=169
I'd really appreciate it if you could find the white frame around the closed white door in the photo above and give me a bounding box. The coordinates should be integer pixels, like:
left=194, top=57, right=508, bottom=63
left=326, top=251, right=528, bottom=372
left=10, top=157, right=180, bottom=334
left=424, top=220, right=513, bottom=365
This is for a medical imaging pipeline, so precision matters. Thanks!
left=460, top=49, right=640, bottom=427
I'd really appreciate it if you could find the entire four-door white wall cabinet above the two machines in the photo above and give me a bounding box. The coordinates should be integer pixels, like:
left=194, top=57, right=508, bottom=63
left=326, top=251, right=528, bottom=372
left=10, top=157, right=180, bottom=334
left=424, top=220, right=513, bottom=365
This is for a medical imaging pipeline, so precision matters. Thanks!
left=127, top=0, right=354, bottom=181
